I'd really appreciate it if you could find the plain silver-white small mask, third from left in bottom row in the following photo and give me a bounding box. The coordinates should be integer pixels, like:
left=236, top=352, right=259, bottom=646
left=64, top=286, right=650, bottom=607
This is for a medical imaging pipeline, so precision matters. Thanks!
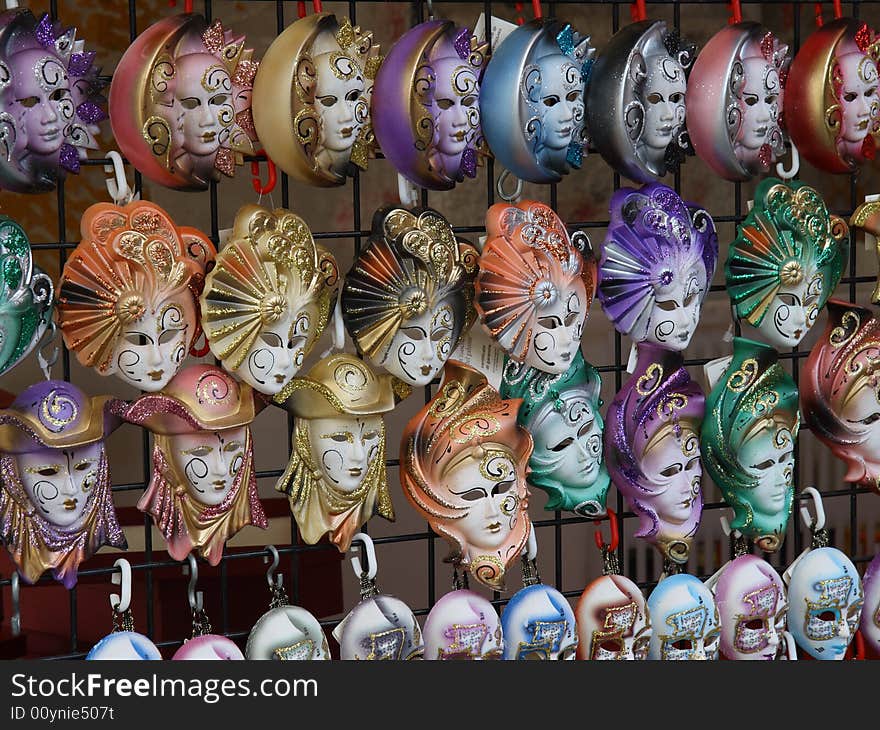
left=245, top=606, right=330, bottom=661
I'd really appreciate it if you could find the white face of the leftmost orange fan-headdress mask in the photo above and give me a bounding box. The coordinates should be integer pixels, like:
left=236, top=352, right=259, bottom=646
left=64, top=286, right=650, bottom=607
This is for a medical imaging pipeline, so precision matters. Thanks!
left=110, top=294, right=189, bottom=393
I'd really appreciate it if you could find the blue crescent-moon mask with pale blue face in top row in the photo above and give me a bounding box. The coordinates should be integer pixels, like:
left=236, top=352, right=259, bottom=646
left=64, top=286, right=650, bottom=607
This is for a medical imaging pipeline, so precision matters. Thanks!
left=480, top=18, right=596, bottom=183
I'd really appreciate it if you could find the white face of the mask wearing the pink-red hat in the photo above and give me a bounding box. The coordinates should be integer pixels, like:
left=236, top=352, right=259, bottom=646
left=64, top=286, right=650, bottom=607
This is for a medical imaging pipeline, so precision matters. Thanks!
left=171, top=427, right=247, bottom=507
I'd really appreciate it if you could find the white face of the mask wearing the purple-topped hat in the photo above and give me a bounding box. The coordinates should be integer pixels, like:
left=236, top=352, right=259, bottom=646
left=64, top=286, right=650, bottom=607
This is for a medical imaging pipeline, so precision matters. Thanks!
left=15, top=441, right=104, bottom=528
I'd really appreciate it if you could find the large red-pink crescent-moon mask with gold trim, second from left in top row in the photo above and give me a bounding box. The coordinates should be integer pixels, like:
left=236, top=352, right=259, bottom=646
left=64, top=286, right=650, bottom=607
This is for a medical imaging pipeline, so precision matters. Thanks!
left=110, top=13, right=257, bottom=190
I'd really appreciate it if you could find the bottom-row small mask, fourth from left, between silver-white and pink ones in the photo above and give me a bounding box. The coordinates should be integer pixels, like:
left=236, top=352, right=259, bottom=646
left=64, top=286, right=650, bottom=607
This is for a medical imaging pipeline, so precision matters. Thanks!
left=333, top=594, right=425, bottom=661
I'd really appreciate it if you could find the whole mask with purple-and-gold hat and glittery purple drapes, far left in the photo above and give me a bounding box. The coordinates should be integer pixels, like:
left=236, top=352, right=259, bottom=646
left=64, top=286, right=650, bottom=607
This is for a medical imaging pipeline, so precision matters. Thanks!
left=0, top=380, right=127, bottom=589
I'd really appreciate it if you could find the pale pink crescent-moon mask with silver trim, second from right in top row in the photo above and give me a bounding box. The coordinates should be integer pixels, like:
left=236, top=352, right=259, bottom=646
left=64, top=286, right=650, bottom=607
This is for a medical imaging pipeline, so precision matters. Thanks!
left=688, top=21, right=791, bottom=181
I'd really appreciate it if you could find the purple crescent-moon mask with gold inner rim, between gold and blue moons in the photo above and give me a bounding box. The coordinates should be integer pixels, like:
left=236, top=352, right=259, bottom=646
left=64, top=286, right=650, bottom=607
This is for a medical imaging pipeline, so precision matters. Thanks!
left=372, top=20, right=488, bottom=190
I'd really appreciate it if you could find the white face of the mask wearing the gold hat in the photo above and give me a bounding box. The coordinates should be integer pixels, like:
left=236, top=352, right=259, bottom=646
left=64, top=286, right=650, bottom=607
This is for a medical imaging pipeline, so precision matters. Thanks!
left=308, top=416, right=385, bottom=493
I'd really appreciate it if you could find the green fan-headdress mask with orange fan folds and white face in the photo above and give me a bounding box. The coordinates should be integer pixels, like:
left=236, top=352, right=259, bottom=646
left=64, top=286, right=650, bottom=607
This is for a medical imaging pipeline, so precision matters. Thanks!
left=724, top=177, right=849, bottom=347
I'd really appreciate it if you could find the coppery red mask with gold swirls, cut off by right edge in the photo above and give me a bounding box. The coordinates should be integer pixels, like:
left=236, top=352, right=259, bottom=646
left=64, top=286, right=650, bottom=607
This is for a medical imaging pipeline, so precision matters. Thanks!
left=800, top=299, right=880, bottom=492
